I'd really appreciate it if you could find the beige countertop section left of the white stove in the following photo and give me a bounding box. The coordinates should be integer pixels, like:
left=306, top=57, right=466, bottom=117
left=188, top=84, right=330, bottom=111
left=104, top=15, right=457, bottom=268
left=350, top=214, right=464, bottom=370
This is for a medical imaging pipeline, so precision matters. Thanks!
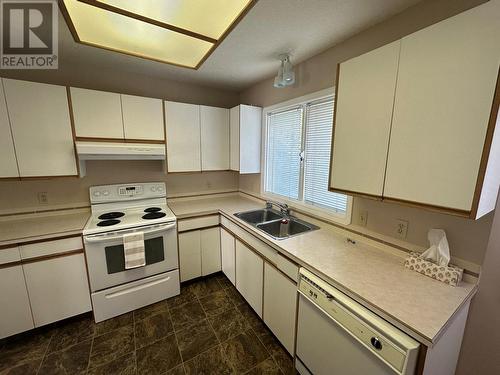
left=0, top=209, right=90, bottom=247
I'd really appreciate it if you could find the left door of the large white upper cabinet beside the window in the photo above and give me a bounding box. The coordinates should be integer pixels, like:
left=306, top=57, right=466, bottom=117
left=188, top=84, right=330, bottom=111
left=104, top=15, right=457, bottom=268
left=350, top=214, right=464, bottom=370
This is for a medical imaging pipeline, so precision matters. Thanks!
left=330, top=41, right=400, bottom=196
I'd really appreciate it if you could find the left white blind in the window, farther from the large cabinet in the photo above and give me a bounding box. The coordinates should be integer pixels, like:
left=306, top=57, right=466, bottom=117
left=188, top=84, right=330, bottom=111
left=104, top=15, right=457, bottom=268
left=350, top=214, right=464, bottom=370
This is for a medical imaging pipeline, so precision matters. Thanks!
left=266, top=107, right=303, bottom=199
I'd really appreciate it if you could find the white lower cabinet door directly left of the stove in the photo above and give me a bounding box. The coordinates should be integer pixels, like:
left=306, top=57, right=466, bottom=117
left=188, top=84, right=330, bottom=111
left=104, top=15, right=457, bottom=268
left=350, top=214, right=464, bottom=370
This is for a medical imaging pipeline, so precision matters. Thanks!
left=23, top=254, right=92, bottom=327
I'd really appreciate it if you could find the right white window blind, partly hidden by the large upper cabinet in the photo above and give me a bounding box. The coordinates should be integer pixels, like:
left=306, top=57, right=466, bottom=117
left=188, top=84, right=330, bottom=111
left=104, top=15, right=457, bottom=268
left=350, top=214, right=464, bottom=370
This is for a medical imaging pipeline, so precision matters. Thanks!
left=304, top=99, right=347, bottom=212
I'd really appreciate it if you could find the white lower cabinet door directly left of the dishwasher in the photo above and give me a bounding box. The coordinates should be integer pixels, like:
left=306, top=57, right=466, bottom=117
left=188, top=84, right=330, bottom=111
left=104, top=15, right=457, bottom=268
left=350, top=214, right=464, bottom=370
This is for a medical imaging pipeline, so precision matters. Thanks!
left=263, top=263, right=297, bottom=356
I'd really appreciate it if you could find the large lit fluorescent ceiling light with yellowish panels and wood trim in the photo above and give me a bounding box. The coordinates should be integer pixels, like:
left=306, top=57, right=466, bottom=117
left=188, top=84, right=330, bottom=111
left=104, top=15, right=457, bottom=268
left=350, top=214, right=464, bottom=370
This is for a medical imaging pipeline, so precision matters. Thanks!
left=60, top=0, right=256, bottom=69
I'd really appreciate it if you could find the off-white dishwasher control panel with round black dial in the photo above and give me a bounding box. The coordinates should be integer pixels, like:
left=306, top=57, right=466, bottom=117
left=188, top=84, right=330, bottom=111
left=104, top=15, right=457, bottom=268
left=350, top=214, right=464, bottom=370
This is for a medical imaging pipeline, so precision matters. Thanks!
left=299, top=271, right=419, bottom=374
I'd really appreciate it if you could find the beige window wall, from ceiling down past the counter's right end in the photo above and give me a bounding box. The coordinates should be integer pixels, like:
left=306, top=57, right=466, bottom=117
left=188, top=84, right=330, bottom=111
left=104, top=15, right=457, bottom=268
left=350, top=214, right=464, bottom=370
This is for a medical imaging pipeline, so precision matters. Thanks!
left=239, top=0, right=500, bottom=375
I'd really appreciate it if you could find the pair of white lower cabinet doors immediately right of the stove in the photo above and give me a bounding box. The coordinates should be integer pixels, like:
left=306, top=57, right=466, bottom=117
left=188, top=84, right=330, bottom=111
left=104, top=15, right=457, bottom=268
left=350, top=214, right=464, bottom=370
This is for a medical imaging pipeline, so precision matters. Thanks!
left=179, top=228, right=221, bottom=282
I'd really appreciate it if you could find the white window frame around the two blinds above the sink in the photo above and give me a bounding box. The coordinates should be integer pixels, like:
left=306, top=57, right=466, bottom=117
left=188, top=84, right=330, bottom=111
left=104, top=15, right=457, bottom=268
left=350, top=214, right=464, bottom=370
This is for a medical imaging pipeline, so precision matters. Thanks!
left=260, top=87, right=353, bottom=225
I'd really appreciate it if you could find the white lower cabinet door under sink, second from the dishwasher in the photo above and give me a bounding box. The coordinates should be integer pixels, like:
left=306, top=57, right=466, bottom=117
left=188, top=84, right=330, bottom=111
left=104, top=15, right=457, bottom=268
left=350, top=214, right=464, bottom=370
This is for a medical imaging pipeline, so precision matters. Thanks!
left=236, top=240, right=264, bottom=317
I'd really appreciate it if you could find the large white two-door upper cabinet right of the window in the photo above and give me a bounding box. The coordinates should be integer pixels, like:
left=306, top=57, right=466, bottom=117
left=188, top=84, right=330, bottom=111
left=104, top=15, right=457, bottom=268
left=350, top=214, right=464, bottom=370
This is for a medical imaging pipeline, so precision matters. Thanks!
left=330, top=1, right=500, bottom=219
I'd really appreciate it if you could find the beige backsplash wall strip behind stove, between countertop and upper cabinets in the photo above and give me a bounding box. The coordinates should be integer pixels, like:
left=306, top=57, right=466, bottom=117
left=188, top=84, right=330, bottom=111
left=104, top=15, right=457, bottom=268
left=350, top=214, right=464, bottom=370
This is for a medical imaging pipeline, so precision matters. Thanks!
left=0, top=161, right=238, bottom=214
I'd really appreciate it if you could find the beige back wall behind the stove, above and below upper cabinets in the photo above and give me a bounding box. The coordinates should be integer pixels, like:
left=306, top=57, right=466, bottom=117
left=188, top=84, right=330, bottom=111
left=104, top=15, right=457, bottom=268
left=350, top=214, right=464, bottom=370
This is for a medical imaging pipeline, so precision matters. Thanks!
left=0, top=57, right=239, bottom=214
